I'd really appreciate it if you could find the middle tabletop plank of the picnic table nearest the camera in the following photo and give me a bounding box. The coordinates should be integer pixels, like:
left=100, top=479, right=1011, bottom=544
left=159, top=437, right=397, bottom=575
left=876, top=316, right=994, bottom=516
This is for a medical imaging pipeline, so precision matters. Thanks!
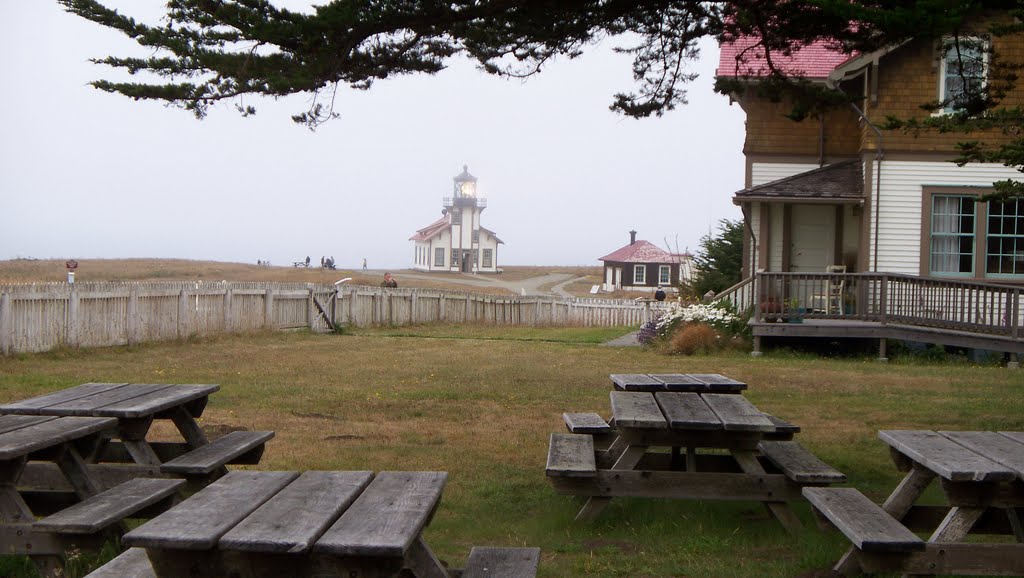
left=218, top=471, right=374, bottom=553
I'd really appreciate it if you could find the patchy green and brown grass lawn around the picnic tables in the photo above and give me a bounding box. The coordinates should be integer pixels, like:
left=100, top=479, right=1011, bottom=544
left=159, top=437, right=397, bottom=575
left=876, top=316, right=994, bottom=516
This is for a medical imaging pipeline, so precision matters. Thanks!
left=0, top=326, right=1024, bottom=577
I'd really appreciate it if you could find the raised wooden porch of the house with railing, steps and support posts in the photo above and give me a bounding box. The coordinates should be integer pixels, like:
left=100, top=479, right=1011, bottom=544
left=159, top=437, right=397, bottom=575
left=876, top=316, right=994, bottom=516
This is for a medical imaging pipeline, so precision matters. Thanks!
left=717, top=272, right=1024, bottom=362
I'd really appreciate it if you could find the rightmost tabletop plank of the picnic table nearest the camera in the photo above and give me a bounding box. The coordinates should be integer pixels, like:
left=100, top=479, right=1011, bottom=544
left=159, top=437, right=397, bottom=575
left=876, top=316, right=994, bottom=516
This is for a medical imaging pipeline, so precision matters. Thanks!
left=313, top=471, right=447, bottom=558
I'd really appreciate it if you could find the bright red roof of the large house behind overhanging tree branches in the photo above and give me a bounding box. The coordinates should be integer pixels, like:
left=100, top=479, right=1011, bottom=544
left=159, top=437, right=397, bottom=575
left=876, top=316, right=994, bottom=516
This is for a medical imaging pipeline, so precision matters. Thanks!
left=716, top=36, right=852, bottom=79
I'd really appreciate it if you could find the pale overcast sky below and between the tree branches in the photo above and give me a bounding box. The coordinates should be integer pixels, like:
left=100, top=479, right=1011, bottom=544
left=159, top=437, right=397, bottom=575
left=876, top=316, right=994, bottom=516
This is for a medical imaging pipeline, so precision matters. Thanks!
left=0, top=0, right=743, bottom=269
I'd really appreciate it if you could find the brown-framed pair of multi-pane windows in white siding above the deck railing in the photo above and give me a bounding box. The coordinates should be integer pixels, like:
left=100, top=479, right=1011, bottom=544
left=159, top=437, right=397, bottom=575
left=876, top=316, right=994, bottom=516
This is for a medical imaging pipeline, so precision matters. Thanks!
left=922, top=190, right=1024, bottom=279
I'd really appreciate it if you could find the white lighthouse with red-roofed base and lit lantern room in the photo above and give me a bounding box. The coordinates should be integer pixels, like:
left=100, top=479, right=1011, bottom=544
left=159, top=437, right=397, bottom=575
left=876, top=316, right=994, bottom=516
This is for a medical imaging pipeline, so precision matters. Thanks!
left=410, top=165, right=503, bottom=273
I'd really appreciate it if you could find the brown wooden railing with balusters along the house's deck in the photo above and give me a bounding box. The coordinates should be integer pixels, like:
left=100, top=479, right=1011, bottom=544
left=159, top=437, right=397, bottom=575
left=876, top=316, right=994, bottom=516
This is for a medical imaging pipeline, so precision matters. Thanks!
left=754, top=273, right=1024, bottom=340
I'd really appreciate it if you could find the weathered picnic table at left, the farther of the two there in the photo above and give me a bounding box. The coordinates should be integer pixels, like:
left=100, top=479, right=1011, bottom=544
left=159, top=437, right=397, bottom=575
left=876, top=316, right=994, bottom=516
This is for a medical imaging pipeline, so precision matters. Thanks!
left=0, top=383, right=273, bottom=487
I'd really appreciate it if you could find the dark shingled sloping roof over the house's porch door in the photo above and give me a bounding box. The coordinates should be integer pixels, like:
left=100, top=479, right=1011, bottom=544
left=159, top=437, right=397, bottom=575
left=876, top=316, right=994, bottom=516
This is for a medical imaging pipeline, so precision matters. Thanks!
left=733, top=160, right=864, bottom=205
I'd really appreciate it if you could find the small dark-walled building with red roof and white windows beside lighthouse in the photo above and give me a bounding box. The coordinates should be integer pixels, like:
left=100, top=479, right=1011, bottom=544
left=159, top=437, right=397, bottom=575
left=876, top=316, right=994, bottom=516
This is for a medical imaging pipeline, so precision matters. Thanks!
left=598, top=231, right=692, bottom=292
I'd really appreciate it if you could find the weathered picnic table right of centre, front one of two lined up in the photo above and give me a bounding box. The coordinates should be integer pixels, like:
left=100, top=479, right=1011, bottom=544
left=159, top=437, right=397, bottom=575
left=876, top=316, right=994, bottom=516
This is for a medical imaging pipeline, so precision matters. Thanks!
left=547, top=390, right=846, bottom=530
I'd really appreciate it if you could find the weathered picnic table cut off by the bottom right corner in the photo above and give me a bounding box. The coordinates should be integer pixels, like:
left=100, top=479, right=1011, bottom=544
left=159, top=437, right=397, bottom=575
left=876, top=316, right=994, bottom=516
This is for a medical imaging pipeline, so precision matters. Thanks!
left=804, top=429, right=1024, bottom=576
